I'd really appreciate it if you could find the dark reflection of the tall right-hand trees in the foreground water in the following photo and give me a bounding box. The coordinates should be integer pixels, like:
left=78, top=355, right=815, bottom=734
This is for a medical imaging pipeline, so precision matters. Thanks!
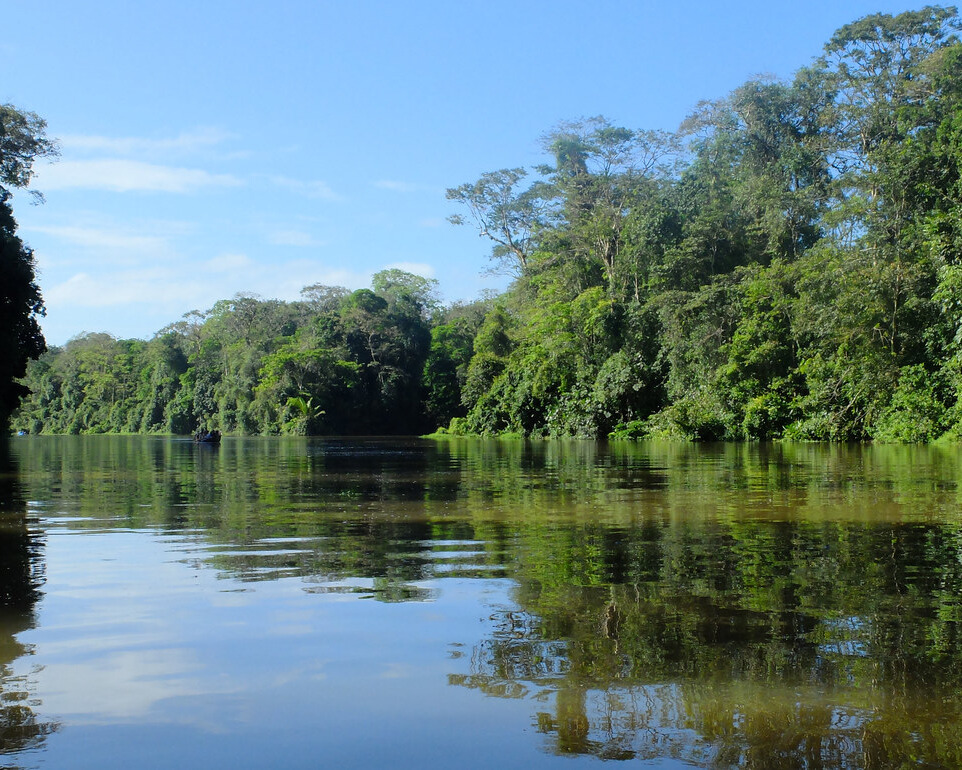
left=450, top=522, right=962, bottom=768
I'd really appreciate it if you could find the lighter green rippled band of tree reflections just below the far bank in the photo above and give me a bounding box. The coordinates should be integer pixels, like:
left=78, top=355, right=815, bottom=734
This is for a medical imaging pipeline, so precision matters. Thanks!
left=18, top=436, right=962, bottom=529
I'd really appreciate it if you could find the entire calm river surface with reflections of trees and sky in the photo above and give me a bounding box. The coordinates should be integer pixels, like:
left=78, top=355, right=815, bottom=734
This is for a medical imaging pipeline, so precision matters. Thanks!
left=0, top=436, right=962, bottom=770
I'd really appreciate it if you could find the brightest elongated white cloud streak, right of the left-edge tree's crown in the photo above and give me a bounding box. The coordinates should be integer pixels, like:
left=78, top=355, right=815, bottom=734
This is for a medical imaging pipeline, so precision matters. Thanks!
left=36, top=158, right=243, bottom=193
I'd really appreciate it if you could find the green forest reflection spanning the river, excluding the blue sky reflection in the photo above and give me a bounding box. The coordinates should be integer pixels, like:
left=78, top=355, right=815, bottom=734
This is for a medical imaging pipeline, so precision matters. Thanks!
left=5, top=437, right=962, bottom=767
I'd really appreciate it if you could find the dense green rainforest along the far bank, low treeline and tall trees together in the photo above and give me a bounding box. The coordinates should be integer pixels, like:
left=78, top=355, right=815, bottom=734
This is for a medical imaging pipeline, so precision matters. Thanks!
left=14, top=6, right=962, bottom=442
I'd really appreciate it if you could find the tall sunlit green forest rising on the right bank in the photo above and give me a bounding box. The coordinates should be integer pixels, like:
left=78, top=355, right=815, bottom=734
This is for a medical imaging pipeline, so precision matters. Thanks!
left=444, top=7, right=962, bottom=442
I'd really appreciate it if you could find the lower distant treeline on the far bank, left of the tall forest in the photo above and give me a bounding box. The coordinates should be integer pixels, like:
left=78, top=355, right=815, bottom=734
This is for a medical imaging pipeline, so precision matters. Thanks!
left=13, top=270, right=485, bottom=434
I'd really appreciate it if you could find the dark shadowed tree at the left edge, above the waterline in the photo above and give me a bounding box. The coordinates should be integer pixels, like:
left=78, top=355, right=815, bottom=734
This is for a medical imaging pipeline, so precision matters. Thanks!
left=0, top=104, right=57, bottom=433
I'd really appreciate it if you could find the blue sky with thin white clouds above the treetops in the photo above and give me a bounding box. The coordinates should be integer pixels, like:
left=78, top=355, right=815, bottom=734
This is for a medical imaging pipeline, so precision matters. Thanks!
left=0, top=0, right=921, bottom=344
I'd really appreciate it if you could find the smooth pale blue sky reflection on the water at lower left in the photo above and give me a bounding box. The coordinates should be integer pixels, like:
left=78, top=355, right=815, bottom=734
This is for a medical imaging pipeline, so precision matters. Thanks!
left=17, top=530, right=568, bottom=768
